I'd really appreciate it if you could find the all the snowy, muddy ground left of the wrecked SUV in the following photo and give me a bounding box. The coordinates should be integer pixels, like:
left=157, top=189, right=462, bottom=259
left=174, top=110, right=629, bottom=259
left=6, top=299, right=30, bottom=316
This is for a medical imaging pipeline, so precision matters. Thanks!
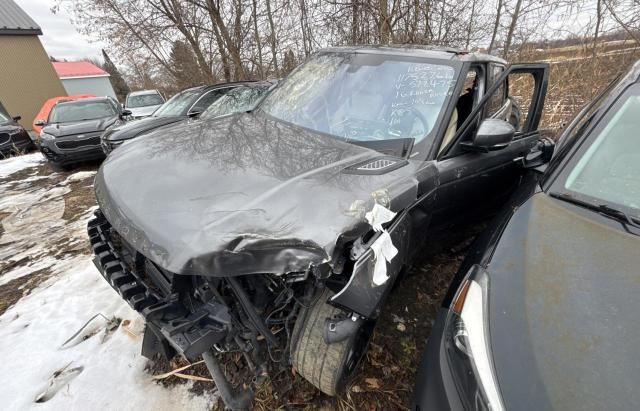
left=0, top=154, right=214, bottom=410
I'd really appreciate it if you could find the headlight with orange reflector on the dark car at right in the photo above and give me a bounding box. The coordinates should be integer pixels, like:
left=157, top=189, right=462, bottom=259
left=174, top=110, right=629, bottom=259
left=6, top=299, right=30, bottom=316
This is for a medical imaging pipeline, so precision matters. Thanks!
left=445, top=266, right=504, bottom=411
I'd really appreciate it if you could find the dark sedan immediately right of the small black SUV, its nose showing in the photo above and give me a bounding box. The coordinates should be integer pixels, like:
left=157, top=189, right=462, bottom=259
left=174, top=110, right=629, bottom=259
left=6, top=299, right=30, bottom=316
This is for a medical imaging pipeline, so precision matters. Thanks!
left=102, top=81, right=266, bottom=154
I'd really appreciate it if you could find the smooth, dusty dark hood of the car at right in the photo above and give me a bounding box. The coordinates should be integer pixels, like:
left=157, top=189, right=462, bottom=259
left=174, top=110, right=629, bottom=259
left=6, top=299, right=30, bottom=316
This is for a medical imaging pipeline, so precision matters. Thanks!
left=487, top=193, right=640, bottom=410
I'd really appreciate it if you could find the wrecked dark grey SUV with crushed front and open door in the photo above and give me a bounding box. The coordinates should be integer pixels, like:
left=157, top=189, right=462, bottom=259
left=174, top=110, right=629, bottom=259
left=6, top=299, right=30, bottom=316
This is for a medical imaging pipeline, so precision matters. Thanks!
left=88, top=47, right=548, bottom=408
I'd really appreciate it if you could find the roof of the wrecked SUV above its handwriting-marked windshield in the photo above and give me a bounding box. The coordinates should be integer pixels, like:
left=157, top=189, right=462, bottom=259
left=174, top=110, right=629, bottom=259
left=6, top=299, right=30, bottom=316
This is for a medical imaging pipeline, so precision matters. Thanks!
left=320, top=44, right=507, bottom=64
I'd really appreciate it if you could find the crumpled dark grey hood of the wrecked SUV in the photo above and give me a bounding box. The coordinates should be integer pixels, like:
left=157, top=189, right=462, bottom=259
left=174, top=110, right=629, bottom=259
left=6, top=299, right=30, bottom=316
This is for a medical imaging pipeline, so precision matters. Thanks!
left=95, top=114, right=421, bottom=276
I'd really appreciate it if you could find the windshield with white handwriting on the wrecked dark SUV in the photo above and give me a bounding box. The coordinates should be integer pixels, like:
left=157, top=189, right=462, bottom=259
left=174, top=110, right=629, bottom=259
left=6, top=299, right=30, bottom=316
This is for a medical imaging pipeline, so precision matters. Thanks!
left=260, top=53, right=456, bottom=142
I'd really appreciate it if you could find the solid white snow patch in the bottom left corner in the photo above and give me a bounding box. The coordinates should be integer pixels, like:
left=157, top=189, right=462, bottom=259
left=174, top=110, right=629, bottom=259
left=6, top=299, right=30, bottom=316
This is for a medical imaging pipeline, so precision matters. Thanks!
left=0, top=256, right=212, bottom=410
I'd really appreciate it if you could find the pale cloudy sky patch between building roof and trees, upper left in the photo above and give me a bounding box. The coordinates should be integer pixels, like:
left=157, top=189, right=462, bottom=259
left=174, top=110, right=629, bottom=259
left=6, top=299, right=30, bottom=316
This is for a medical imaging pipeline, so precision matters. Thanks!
left=14, top=0, right=102, bottom=60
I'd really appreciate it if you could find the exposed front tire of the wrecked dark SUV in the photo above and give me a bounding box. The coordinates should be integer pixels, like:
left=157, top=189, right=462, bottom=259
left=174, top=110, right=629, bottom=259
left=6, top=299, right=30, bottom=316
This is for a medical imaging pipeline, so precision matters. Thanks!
left=291, top=289, right=374, bottom=396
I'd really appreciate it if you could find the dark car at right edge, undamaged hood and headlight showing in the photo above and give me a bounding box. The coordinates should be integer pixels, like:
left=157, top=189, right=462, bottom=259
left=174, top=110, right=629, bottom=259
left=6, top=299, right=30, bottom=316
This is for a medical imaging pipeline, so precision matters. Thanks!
left=414, top=63, right=640, bottom=410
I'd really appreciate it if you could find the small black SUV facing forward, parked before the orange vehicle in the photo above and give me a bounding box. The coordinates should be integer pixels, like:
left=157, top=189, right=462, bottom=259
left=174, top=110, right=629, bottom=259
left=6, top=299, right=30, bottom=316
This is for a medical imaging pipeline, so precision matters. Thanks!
left=40, top=97, right=128, bottom=166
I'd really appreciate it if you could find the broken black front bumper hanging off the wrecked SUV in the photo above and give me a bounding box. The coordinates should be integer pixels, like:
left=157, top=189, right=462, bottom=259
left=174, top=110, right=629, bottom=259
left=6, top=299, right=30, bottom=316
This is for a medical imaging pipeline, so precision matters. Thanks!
left=87, top=210, right=231, bottom=360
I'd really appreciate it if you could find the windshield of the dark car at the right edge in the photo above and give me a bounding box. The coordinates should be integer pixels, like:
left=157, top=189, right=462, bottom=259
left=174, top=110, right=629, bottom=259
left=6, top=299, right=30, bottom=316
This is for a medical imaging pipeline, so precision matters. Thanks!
left=561, top=84, right=640, bottom=217
